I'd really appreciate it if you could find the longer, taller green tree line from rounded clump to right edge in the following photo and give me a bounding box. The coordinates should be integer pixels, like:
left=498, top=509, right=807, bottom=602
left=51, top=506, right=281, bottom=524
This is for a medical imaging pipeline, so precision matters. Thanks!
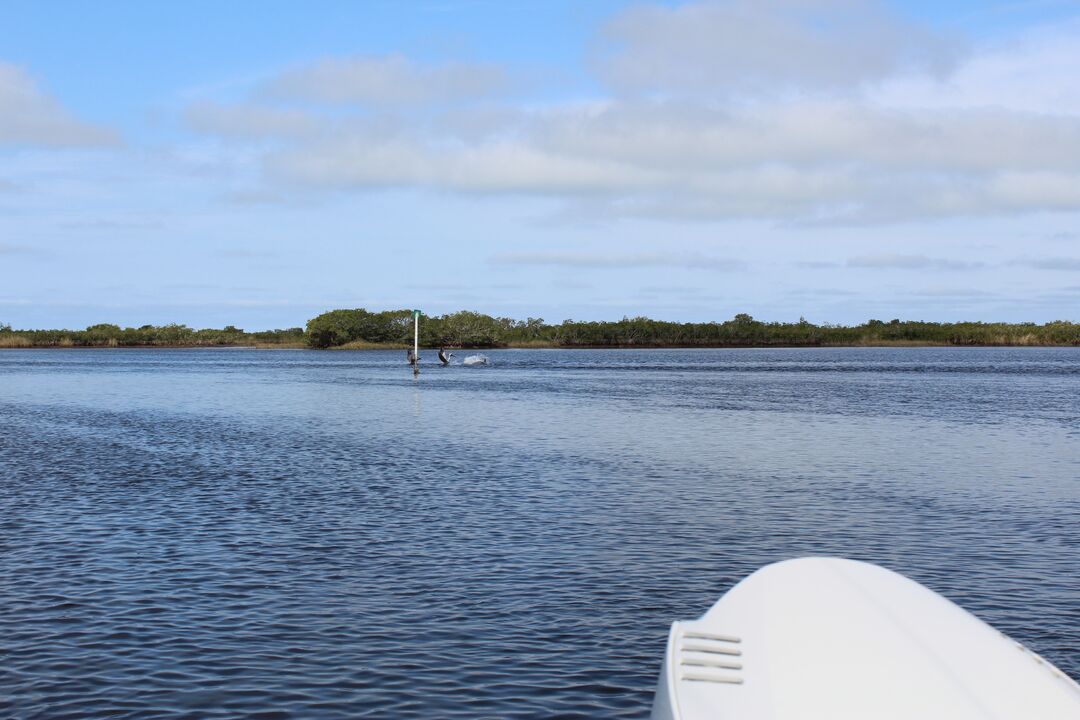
left=307, top=309, right=1080, bottom=348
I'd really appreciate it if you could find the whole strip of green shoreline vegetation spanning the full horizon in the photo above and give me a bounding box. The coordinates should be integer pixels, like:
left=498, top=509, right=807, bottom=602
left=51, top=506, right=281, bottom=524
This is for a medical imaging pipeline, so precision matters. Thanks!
left=0, top=309, right=1080, bottom=350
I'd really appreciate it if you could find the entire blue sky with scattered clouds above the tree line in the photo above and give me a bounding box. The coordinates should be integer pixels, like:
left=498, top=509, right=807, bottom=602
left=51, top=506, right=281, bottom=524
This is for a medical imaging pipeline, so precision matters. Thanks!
left=0, top=0, right=1080, bottom=330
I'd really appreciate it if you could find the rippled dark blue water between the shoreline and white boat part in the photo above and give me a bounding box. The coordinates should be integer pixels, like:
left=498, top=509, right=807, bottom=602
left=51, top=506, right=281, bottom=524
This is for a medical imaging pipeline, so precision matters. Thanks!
left=0, top=349, right=1080, bottom=718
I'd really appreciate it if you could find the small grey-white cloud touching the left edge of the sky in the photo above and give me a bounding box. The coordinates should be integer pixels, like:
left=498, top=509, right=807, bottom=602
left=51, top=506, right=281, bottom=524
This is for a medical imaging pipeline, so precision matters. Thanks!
left=0, top=63, right=117, bottom=147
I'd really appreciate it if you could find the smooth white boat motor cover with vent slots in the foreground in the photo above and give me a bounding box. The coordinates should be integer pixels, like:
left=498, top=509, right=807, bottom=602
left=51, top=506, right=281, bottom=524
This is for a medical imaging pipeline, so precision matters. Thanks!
left=652, top=558, right=1080, bottom=720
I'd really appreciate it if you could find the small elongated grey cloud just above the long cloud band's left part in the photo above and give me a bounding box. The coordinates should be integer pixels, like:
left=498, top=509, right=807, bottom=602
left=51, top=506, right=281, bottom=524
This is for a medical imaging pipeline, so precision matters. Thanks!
left=266, top=55, right=507, bottom=106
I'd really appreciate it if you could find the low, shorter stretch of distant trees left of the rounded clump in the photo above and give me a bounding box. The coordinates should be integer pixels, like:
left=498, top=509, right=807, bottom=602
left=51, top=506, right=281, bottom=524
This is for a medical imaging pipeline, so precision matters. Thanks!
left=0, top=324, right=307, bottom=348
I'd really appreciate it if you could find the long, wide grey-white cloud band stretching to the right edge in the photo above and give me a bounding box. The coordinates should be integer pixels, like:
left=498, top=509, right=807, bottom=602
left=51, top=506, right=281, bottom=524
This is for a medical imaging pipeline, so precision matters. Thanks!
left=252, top=100, right=1080, bottom=221
